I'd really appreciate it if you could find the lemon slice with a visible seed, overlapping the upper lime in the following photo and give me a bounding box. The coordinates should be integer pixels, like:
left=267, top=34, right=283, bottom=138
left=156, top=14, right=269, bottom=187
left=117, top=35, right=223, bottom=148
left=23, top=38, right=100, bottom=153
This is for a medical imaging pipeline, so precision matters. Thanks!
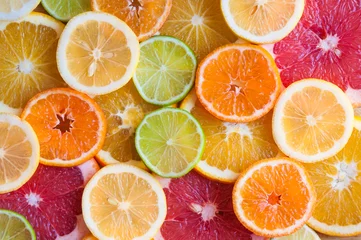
left=56, top=12, right=140, bottom=95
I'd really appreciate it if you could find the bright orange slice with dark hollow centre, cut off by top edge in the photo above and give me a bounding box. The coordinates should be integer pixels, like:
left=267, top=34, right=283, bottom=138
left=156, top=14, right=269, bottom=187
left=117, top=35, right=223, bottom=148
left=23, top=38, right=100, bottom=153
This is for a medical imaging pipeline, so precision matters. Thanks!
left=91, top=0, right=172, bottom=41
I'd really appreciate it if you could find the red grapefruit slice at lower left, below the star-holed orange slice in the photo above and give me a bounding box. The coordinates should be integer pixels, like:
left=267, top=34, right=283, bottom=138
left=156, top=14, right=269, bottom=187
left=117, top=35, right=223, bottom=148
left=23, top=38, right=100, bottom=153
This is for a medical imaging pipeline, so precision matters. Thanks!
left=0, top=159, right=99, bottom=240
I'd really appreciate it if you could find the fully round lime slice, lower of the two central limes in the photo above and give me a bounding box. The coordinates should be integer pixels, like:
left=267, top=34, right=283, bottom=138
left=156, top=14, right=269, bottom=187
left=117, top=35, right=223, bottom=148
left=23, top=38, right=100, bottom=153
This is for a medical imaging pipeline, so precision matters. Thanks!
left=135, top=108, right=205, bottom=178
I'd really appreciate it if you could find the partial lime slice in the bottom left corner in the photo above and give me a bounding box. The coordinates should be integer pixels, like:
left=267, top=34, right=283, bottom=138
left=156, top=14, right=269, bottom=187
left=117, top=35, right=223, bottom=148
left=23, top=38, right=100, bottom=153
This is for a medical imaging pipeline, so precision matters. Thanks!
left=0, top=209, right=36, bottom=240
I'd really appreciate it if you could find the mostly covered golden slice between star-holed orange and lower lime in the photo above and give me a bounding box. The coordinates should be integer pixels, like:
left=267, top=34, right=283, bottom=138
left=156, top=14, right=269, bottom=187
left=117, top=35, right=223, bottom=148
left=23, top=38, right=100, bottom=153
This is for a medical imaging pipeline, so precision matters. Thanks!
left=94, top=81, right=157, bottom=165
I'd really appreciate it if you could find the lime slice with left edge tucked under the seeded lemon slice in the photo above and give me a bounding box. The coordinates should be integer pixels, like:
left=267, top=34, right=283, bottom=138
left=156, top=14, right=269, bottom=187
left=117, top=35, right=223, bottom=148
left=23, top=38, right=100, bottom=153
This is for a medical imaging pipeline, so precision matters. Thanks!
left=133, top=36, right=197, bottom=106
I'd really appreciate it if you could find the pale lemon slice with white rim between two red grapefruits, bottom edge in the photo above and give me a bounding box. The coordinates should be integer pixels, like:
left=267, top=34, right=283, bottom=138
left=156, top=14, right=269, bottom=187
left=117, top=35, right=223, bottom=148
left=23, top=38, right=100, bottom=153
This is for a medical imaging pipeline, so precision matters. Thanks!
left=82, top=164, right=167, bottom=240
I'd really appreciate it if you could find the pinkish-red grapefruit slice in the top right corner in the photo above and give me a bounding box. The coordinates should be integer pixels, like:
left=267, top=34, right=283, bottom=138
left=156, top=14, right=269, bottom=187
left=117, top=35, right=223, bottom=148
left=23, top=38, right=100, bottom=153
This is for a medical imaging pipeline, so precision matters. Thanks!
left=266, top=0, right=361, bottom=103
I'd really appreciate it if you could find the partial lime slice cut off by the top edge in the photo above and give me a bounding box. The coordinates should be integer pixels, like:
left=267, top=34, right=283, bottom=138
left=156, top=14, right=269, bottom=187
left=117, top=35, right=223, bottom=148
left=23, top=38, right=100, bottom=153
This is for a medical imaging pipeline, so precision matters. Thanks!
left=41, top=0, right=91, bottom=22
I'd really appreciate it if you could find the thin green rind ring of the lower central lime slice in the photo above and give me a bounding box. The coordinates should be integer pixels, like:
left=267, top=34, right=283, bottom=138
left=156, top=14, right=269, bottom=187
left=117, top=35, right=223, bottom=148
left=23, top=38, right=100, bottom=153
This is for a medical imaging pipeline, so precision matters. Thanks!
left=135, top=107, right=205, bottom=178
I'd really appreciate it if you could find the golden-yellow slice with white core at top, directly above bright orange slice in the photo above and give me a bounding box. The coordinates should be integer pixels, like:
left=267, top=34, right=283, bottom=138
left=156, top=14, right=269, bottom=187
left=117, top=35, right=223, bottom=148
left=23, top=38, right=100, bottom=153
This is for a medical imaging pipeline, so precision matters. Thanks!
left=160, top=0, right=237, bottom=60
